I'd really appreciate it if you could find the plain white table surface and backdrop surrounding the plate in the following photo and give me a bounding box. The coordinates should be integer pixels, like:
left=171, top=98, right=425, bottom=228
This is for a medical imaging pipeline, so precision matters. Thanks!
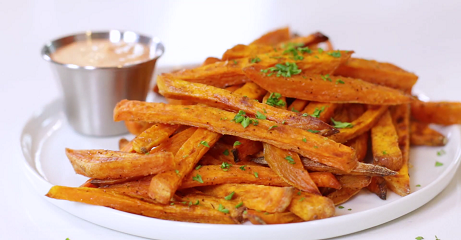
left=0, top=0, right=461, bottom=240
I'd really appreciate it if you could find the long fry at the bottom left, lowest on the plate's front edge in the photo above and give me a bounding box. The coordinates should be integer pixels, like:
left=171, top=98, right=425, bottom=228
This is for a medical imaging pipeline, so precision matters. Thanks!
left=46, top=186, right=237, bottom=224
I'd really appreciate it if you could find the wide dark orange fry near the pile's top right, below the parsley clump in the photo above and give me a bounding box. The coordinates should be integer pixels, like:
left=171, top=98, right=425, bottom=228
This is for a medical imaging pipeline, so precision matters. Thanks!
left=243, top=65, right=410, bottom=105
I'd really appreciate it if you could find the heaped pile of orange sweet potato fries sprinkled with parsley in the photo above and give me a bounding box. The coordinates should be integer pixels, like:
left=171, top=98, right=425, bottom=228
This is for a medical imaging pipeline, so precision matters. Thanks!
left=47, top=28, right=461, bottom=224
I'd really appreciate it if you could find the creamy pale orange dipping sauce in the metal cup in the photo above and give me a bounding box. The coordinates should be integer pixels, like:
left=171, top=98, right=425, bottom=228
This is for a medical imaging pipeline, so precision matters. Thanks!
left=51, top=39, right=150, bottom=67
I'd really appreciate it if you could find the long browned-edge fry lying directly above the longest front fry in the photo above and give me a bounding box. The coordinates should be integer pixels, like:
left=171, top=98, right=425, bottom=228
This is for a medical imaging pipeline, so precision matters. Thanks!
left=157, top=76, right=335, bottom=135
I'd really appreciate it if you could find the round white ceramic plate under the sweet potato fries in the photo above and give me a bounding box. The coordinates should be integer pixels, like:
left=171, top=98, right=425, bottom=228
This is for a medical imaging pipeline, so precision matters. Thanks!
left=21, top=92, right=461, bottom=240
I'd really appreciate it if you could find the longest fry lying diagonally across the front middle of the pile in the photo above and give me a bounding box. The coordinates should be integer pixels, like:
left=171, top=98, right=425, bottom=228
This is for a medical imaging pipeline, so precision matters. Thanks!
left=114, top=100, right=357, bottom=172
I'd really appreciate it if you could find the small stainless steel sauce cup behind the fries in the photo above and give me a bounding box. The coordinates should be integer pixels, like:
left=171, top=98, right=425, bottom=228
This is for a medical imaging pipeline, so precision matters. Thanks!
left=42, top=30, right=164, bottom=137
